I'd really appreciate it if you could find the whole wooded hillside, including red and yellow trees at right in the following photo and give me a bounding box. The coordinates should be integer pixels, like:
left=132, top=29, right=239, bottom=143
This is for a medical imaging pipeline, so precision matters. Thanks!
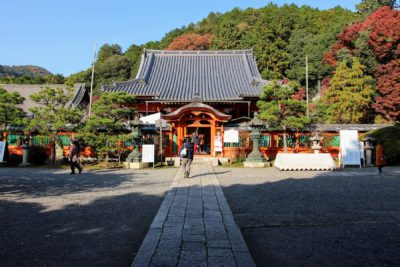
left=67, top=0, right=400, bottom=123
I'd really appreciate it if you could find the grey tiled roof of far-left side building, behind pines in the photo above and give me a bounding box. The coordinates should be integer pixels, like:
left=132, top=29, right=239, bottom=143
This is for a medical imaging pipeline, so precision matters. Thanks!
left=0, top=83, right=86, bottom=115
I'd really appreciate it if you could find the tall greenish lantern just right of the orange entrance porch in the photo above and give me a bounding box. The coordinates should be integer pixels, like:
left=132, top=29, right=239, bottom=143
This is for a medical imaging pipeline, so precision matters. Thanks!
left=243, top=113, right=268, bottom=168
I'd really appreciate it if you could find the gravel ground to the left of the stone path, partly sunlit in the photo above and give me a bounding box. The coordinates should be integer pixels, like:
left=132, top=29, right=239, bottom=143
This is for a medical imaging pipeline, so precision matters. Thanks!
left=0, top=168, right=176, bottom=266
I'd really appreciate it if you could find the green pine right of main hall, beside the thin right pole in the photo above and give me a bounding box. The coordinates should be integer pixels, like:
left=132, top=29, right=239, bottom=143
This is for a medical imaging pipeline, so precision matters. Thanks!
left=257, top=81, right=310, bottom=148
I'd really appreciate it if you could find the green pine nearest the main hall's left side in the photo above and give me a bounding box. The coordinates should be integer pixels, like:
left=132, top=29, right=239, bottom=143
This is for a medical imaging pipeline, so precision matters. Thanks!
left=78, top=92, right=135, bottom=162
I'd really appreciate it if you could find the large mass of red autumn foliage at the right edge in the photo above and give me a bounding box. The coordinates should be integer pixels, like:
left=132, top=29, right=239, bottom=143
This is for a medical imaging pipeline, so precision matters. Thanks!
left=324, top=6, right=400, bottom=121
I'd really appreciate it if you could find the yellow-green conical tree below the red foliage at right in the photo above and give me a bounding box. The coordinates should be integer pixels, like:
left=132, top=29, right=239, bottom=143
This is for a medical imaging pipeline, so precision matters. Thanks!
left=322, top=57, right=375, bottom=123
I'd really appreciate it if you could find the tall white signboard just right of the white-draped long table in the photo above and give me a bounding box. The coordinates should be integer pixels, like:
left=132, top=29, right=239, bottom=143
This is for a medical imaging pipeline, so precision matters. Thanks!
left=340, top=130, right=361, bottom=167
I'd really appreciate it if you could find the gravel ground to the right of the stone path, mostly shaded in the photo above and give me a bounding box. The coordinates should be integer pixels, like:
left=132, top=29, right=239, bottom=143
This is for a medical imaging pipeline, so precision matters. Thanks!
left=215, top=168, right=400, bottom=266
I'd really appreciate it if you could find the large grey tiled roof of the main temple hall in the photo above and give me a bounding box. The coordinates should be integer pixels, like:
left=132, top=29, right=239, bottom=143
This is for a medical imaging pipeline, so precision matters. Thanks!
left=102, top=50, right=268, bottom=102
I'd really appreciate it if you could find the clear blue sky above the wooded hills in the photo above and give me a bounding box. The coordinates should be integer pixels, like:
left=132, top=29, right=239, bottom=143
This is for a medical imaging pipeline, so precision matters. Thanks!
left=0, top=0, right=360, bottom=76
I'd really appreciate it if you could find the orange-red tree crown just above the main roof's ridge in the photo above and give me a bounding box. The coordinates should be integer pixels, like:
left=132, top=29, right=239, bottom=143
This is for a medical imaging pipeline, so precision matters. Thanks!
left=167, top=33, right=212, bottom=50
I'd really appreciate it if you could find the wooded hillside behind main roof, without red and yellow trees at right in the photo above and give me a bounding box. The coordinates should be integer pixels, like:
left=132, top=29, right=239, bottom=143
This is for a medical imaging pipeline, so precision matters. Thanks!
left=68, top=4, right=360, bottom=94
